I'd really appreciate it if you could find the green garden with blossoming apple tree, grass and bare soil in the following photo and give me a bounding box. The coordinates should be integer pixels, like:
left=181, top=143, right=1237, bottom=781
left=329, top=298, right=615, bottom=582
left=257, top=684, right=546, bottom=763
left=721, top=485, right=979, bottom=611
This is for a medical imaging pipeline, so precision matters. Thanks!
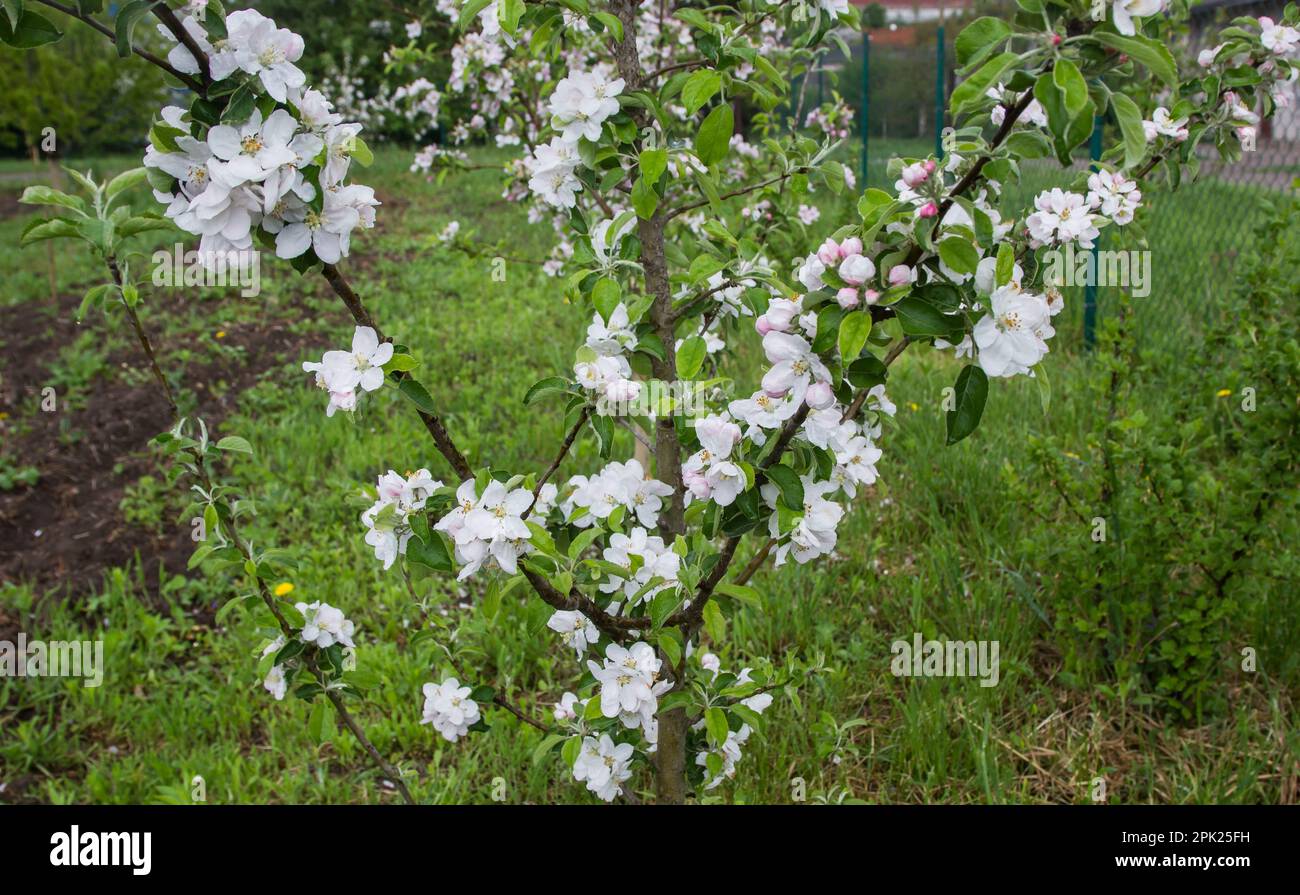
left=0, top=0, right=1300, bottom=804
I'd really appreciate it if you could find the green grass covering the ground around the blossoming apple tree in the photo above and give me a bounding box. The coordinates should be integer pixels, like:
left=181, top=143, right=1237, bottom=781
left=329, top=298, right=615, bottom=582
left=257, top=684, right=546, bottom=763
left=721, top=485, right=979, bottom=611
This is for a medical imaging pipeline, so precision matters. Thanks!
left=0, top=144, right=1300, bottom=803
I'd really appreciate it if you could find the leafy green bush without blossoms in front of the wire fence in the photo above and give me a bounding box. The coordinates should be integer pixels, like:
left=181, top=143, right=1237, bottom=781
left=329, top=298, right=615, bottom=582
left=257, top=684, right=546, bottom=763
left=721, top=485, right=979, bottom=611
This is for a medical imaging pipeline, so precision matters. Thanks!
left=1006, top=202, right=1300, bottom=719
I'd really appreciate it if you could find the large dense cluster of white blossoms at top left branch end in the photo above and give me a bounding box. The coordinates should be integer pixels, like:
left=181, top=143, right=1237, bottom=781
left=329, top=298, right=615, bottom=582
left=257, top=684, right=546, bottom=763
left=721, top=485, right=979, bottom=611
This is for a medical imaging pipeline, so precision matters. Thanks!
left=144, top=9, right=380, bottom=264
